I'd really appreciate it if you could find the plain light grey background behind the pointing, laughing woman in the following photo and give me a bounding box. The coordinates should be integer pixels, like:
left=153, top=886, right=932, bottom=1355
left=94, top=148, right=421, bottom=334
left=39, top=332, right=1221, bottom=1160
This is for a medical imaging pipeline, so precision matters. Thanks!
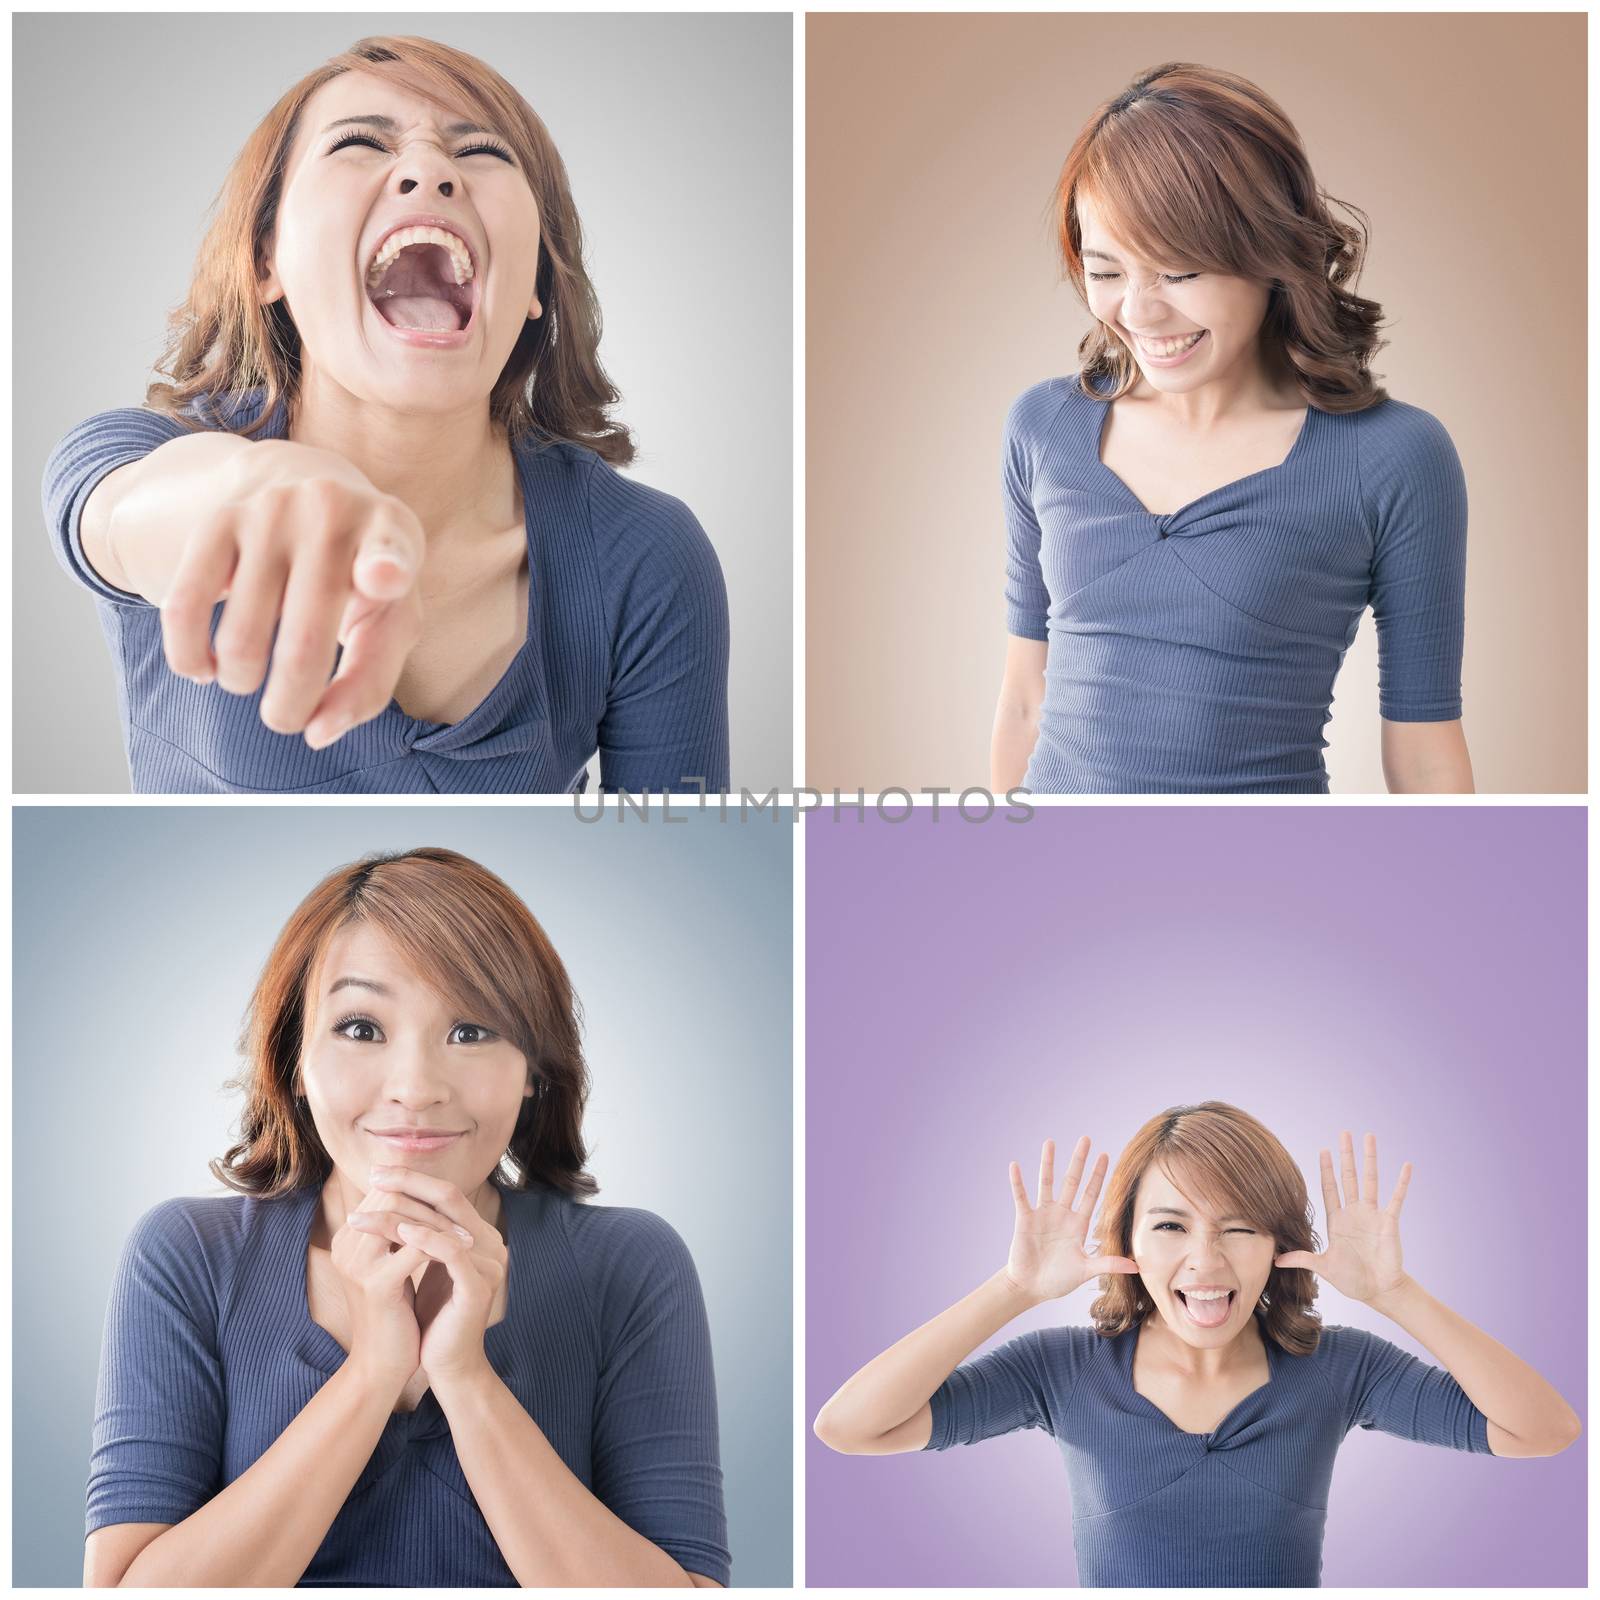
left=11, top=13, right=794, bottom=794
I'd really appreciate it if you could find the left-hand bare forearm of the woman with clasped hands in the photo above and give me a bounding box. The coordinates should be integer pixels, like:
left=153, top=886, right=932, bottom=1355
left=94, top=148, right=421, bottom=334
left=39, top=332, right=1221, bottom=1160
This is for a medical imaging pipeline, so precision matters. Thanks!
left=122, top=1362, right=395, bottom=1589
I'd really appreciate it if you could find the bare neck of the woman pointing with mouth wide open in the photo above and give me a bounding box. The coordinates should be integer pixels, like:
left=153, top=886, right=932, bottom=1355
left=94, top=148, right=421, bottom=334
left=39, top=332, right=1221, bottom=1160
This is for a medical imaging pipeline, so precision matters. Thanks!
left=288, top=368, right=515, bottom=549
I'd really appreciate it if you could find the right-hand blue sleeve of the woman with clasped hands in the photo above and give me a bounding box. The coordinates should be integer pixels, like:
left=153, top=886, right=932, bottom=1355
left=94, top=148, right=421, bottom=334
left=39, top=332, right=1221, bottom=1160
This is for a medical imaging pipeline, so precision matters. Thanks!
left=590, top=1208, right=731, bottom=1586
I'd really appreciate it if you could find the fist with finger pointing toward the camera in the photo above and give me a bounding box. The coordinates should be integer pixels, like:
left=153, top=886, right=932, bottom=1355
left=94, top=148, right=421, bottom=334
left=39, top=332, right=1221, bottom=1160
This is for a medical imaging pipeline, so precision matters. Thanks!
left=128, top=440, right=426, bottom=749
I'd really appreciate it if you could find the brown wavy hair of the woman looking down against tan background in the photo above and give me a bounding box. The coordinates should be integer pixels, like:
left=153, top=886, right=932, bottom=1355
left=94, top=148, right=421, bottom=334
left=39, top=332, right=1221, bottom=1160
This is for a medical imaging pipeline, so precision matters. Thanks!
left=1053, top=61, right=1389, bottom=411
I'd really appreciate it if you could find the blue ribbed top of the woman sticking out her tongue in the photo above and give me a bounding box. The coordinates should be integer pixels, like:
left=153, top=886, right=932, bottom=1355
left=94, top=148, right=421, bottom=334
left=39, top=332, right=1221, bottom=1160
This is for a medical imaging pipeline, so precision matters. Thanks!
left=926, top=1328, right=1490, bottom=1589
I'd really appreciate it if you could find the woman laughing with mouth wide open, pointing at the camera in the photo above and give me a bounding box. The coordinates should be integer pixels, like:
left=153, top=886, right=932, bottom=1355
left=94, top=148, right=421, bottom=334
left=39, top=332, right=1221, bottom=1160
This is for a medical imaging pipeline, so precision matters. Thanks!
left=45, top=38, right=728, bottom=794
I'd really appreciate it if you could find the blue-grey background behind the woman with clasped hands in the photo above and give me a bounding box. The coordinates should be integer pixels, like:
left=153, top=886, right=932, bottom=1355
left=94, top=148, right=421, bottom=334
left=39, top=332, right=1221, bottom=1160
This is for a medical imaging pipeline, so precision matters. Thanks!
left=11, top=803, right=794, bottom=1587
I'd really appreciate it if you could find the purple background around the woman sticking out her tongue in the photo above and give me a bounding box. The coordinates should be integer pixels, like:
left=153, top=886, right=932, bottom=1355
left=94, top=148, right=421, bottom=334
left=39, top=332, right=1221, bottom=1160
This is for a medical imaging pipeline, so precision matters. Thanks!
left=805, top=806, right=1587, bottom=1587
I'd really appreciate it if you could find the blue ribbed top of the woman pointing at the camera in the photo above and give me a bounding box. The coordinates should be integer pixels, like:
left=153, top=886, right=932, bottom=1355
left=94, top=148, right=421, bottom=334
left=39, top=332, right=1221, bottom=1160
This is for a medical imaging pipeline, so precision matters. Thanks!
left=43, top=390, right=728, bottom=794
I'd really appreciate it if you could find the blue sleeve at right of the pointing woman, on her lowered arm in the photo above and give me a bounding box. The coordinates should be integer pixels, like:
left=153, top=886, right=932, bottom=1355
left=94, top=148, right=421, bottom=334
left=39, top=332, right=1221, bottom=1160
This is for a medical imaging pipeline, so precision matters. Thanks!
left=590, top=461, right=728, bottom=794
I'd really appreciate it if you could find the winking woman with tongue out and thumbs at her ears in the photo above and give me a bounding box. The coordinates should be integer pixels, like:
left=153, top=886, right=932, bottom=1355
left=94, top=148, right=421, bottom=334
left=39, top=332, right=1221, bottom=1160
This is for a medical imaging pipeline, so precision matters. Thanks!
left=816, top=1101, right=1579, bottom=1587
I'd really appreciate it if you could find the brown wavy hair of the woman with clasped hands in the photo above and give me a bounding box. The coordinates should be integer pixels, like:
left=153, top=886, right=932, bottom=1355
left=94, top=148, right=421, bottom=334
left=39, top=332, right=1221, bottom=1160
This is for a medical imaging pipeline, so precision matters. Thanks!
left=210, top=848, right=598, bottom=1198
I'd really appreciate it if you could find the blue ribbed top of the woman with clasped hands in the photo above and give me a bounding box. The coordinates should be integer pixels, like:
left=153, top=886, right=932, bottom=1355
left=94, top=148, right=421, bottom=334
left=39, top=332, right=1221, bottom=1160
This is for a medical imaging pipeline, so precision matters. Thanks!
left=86, top=1184, right=730, bottom=1589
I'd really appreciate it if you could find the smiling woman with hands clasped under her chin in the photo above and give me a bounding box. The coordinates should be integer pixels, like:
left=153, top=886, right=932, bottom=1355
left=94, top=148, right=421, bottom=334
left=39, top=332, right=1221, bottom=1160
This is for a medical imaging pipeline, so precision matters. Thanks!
left=83, top=850, right=728, bottom=1587
